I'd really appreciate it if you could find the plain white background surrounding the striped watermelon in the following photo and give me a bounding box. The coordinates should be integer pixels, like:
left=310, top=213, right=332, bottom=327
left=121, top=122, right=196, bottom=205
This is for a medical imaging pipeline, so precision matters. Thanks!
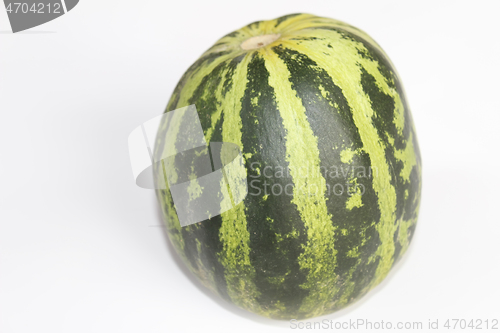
left=0, top=0, right=500, bottom=333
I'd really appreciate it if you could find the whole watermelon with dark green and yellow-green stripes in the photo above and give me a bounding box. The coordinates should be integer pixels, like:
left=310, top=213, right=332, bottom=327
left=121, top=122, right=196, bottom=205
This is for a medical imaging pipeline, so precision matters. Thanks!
left=155, top=14, right=421, bottom=319
